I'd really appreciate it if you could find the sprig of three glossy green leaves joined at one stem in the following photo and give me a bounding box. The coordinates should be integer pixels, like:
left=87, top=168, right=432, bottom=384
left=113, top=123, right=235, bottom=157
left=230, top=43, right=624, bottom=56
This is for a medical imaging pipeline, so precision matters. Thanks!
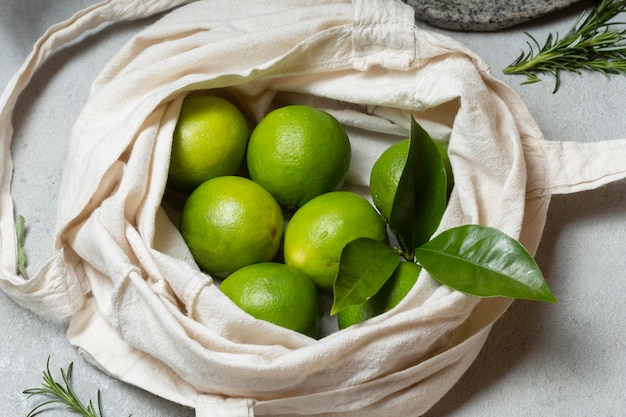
left=331, top=118, right=556, bottom=322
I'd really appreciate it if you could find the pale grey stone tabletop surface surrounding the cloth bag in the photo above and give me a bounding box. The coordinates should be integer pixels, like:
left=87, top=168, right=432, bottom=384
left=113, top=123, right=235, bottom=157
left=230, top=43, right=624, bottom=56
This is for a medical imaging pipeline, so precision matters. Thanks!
left=0, top=0, right=626, bottom=417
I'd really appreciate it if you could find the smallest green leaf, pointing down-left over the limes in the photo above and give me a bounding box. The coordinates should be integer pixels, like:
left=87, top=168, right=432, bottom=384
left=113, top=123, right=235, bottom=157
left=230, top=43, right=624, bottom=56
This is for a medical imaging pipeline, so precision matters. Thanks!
left=330, top=238, right=400, bottom=315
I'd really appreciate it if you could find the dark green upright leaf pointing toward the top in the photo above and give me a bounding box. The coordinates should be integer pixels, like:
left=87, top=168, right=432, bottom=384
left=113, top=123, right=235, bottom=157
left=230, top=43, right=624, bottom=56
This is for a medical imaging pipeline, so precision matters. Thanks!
left=389, top=116, right=447, bottom=255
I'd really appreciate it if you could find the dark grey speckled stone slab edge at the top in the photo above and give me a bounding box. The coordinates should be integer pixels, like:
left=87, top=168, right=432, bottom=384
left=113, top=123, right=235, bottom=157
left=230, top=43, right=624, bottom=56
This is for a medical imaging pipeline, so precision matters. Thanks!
left=403, top=0, right=583, bottom=31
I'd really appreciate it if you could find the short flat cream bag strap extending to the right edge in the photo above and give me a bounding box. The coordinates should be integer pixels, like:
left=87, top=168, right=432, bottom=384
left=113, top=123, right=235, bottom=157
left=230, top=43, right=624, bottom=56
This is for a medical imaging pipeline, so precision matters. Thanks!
left=544, top=139, right=626, bottom=194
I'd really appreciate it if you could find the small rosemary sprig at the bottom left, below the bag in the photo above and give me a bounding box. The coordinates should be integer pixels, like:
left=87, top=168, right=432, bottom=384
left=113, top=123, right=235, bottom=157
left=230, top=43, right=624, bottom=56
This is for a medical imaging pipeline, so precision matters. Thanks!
left=24, top=357, right=130, bottom=417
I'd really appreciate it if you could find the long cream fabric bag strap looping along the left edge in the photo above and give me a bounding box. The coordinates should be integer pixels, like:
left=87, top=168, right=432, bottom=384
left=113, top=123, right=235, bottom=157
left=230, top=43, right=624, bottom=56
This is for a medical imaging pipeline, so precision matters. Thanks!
left=0, top=0, right=194, bottom=308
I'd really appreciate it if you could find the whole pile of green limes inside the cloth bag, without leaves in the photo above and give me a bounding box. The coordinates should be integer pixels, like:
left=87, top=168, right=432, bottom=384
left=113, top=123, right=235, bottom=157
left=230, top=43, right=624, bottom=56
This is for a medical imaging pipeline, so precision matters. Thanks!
left=168, top=93, right=438, bottom=337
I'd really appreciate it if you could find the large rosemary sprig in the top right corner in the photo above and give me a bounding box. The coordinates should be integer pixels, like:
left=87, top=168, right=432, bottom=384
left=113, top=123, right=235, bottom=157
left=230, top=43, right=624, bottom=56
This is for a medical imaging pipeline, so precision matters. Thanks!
left=503, top=0, right=626, bottom=92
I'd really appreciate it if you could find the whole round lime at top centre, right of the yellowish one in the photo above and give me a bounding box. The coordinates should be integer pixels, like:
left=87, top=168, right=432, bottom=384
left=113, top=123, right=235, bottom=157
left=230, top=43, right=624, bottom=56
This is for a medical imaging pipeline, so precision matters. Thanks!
left=246, top=105, right=351, bottom=207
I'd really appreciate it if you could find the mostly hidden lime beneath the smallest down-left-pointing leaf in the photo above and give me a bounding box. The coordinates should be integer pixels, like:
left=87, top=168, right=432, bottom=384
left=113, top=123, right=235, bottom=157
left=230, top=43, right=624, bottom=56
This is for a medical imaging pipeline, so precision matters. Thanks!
left=337, top=262, right=422, bottom=329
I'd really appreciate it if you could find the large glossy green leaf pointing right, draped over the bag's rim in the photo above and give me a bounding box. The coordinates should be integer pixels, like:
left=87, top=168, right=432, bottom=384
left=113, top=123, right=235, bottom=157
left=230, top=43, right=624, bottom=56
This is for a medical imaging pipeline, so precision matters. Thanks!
left=415, top=225, right=557, bottom=302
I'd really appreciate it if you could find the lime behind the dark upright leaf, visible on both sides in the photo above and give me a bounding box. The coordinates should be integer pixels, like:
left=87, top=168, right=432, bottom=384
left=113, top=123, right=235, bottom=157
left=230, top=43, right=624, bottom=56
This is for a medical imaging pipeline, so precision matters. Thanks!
left=370, top=139, right=454, bottom=220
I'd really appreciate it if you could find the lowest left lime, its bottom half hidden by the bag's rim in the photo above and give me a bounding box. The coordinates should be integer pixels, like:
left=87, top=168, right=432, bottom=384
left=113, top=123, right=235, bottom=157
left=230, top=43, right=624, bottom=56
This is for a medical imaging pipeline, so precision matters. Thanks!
left=220, top=262, right=322, bottom=337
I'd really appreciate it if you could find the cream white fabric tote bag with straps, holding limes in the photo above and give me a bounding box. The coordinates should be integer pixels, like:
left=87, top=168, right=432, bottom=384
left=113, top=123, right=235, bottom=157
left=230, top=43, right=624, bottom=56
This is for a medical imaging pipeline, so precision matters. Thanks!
left=0, top=0, right=626, bottom=417
